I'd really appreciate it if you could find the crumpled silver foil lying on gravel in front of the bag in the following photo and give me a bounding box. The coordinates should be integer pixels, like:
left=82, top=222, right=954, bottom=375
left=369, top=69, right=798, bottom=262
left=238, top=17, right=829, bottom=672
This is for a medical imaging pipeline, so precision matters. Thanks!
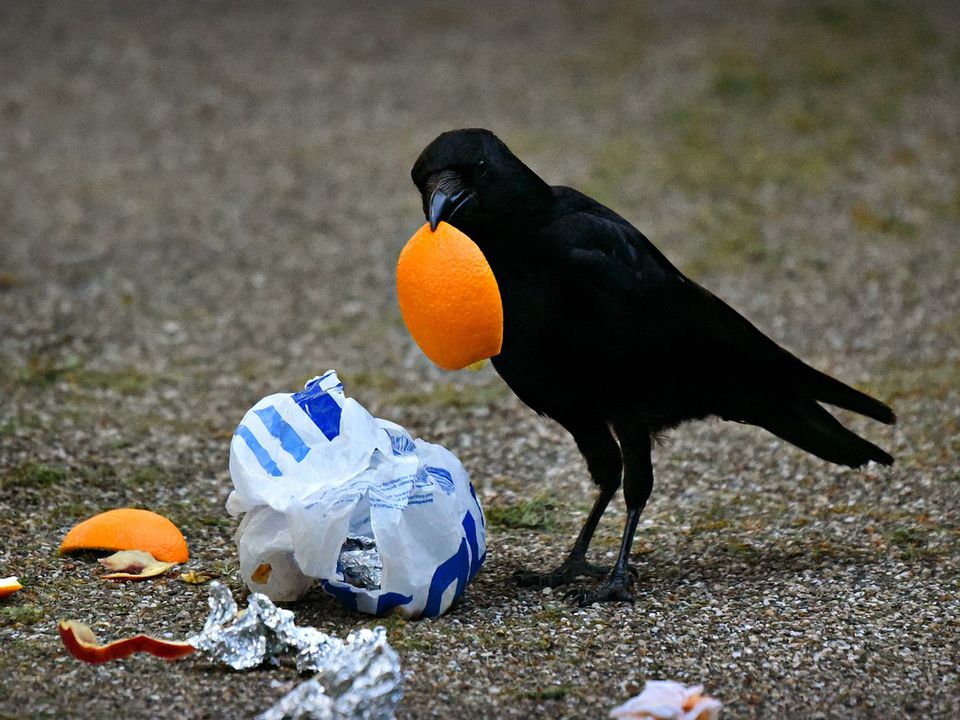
left=187, top=582, right=403, bottom=720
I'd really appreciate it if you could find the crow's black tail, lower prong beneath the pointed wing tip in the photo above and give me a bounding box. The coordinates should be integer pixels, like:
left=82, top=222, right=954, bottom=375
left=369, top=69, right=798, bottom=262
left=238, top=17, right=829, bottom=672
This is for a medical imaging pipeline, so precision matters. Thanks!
left=753, top=400, right=893, bottom=468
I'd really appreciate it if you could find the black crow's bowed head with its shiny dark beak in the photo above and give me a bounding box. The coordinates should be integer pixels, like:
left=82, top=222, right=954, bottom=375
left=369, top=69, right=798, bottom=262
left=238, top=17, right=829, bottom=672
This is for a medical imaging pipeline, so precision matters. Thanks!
left=410, top=129, right=551, bottom=235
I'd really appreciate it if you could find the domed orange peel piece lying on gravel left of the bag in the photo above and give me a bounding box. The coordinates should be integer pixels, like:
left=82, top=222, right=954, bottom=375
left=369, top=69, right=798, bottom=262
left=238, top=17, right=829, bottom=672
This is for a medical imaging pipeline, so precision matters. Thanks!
left=60, top=508, right=190, bottom=563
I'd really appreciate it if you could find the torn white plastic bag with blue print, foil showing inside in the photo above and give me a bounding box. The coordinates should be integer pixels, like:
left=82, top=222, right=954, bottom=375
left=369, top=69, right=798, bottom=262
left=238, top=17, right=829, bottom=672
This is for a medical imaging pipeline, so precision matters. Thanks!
left=227, top=370, right=486, bottom=617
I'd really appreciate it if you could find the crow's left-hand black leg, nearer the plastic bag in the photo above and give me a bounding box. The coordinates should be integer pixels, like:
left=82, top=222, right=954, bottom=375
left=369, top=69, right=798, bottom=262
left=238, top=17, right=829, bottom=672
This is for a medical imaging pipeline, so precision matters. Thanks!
left=516, top=423, right=623, bottom=588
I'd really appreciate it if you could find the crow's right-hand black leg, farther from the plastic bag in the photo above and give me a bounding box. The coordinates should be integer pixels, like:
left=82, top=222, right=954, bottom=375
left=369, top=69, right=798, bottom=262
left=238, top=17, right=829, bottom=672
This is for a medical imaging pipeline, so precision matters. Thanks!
left=570, top=424, right=653, bottom=607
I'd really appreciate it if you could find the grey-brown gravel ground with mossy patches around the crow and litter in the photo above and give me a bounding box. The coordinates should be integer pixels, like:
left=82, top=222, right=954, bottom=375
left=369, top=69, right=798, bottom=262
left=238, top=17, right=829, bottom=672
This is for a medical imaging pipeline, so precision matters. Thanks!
left=0, top=0, right=960, bottom=718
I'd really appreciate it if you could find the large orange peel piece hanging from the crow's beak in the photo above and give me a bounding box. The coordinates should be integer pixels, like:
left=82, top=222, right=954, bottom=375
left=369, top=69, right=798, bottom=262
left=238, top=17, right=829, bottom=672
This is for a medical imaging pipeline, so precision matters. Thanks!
left=397, top=222, right=503, bottom=370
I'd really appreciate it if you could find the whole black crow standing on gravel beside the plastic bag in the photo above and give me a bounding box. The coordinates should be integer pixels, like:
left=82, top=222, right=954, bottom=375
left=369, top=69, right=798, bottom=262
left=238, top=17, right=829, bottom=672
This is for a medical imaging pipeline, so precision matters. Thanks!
left=411, top=129, right=896, bottom=605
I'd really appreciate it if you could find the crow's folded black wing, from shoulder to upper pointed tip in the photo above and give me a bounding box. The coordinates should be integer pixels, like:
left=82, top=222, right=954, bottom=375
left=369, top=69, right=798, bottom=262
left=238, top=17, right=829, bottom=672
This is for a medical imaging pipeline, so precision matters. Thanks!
left=545, top=191, right=893, bottom=422
